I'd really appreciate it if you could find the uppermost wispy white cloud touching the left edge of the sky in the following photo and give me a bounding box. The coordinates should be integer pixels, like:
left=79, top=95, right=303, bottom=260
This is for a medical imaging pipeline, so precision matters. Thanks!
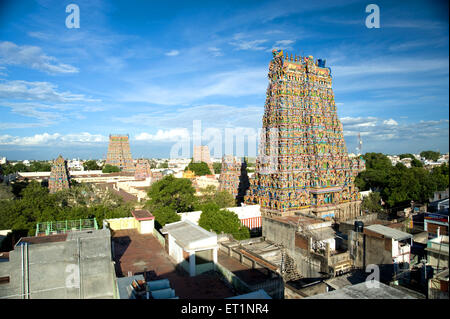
left=0, top=41, right=78, bottom=74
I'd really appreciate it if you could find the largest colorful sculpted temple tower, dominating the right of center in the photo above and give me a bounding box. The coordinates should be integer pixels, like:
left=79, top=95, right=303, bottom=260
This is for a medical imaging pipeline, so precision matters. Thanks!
left=246, top=50, right=365, bottom=220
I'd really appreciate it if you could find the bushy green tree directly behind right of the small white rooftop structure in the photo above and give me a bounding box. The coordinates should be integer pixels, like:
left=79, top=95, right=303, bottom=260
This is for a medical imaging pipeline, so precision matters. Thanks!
left=198, top=203, right=250, bottom=240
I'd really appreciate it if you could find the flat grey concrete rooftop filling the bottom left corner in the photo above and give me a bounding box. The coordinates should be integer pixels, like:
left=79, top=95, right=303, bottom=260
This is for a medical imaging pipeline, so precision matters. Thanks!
left=0, top=229, right=115, bottom=299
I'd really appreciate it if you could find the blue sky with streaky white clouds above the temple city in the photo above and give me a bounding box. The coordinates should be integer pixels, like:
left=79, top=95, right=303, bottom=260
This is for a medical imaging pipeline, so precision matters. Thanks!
left=0, top=0, right=449, bottom=160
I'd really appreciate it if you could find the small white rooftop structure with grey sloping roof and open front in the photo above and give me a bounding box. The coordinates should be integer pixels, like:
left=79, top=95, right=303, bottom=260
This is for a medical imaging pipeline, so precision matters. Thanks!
left=161, top=220, right=219, bottom=277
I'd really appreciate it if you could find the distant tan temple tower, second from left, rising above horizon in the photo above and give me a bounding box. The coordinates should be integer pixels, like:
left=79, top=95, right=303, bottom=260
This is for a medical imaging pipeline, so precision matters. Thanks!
left=105, top=135, right=135, bottom=172
